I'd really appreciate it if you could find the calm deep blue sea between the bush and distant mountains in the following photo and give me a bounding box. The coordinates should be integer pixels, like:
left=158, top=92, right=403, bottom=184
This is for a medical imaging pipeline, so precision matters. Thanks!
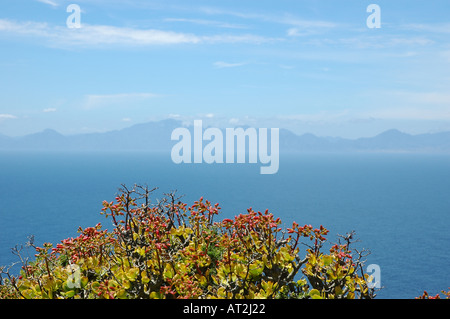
left=0, top=152, right=450, bottom=299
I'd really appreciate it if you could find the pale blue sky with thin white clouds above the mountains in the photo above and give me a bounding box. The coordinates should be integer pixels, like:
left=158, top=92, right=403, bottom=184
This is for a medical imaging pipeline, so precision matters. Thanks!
left=0, top=0, right=450, bottom=138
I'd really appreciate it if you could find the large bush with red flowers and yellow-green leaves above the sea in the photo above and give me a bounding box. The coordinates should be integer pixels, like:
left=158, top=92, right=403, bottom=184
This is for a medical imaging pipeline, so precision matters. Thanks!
left=0, top=185, right=375, bottom=299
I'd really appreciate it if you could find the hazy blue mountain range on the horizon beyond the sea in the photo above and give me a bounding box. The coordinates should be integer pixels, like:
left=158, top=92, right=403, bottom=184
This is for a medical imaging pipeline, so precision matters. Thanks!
left=0, top=119, right=450, bottom=153
